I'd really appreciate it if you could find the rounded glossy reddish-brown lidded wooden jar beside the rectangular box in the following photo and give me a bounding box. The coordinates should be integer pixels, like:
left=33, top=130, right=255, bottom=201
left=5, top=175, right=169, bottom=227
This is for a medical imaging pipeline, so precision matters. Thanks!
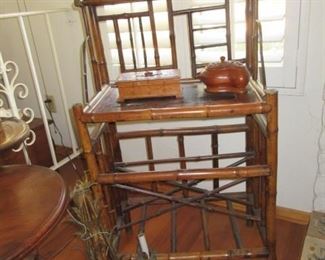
left=198, top=56, right=250, bottom=94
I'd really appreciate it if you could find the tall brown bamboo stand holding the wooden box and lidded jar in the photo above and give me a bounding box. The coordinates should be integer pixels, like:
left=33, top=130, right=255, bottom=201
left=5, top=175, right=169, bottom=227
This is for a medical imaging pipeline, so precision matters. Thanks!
left=73, top=0, right=278, bottom=259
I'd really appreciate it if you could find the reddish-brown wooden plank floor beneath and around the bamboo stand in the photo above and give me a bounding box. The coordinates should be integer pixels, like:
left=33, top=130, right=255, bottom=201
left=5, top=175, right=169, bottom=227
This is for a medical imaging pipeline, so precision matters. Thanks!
left=39, top=160, right=307, bottom=260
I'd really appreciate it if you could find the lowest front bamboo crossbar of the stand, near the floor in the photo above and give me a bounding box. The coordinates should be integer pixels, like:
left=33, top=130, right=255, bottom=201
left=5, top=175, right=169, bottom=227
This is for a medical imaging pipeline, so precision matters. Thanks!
left=122, top=247, right=269, bottom=260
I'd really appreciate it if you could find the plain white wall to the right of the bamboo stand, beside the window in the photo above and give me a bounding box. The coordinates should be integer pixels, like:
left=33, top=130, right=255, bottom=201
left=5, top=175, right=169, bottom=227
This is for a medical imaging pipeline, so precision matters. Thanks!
left=278, top=0, right=325, bottom=211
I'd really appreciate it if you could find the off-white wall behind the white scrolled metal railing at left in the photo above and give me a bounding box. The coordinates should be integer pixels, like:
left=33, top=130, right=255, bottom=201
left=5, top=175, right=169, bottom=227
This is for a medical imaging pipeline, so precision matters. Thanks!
left=0, top=0, right=91, bottom=147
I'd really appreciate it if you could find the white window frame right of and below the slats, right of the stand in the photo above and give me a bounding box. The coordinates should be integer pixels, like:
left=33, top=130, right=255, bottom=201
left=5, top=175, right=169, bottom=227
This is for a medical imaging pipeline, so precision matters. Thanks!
left=266, top=0, right=311, bottom=95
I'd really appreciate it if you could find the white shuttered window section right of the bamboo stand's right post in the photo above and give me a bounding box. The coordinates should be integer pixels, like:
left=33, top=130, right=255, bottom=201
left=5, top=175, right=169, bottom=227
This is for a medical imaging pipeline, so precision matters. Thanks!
left=259, top=0, right=310, bottom=95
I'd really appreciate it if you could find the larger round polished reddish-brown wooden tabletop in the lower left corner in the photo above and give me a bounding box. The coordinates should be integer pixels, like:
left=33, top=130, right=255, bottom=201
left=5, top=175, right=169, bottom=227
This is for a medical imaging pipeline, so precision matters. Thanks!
left=0, top=165, right=68, bottom=259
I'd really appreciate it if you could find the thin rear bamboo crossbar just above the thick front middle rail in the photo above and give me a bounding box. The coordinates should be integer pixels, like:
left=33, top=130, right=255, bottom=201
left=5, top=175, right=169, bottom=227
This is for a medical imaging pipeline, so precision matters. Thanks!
left=114, top=152, right=254, bottom=167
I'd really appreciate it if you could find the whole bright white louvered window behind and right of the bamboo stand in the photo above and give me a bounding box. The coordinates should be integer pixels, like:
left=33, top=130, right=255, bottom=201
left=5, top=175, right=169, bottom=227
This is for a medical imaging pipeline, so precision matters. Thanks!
left=99, top=0, right=309, bottom=94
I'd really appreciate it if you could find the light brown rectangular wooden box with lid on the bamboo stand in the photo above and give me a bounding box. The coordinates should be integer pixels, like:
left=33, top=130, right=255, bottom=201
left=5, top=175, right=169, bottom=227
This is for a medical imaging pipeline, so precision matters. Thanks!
left=116, top=69, right=181, bottom=102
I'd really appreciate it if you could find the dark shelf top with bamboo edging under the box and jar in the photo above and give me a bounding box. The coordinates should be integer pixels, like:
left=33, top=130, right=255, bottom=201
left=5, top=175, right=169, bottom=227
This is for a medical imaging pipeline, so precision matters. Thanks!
left=82, top=84, right=270, bottom=122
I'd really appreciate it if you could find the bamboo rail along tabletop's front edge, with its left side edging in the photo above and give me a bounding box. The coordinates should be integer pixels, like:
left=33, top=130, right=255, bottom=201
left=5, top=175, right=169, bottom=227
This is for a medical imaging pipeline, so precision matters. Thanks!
left=80, top=85, right=272, bottom=123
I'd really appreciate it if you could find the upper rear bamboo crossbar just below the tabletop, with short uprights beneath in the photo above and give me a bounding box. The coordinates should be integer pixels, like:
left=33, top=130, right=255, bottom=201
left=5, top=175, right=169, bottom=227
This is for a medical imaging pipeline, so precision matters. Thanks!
left=117, top=124, right=248, bottom=140
